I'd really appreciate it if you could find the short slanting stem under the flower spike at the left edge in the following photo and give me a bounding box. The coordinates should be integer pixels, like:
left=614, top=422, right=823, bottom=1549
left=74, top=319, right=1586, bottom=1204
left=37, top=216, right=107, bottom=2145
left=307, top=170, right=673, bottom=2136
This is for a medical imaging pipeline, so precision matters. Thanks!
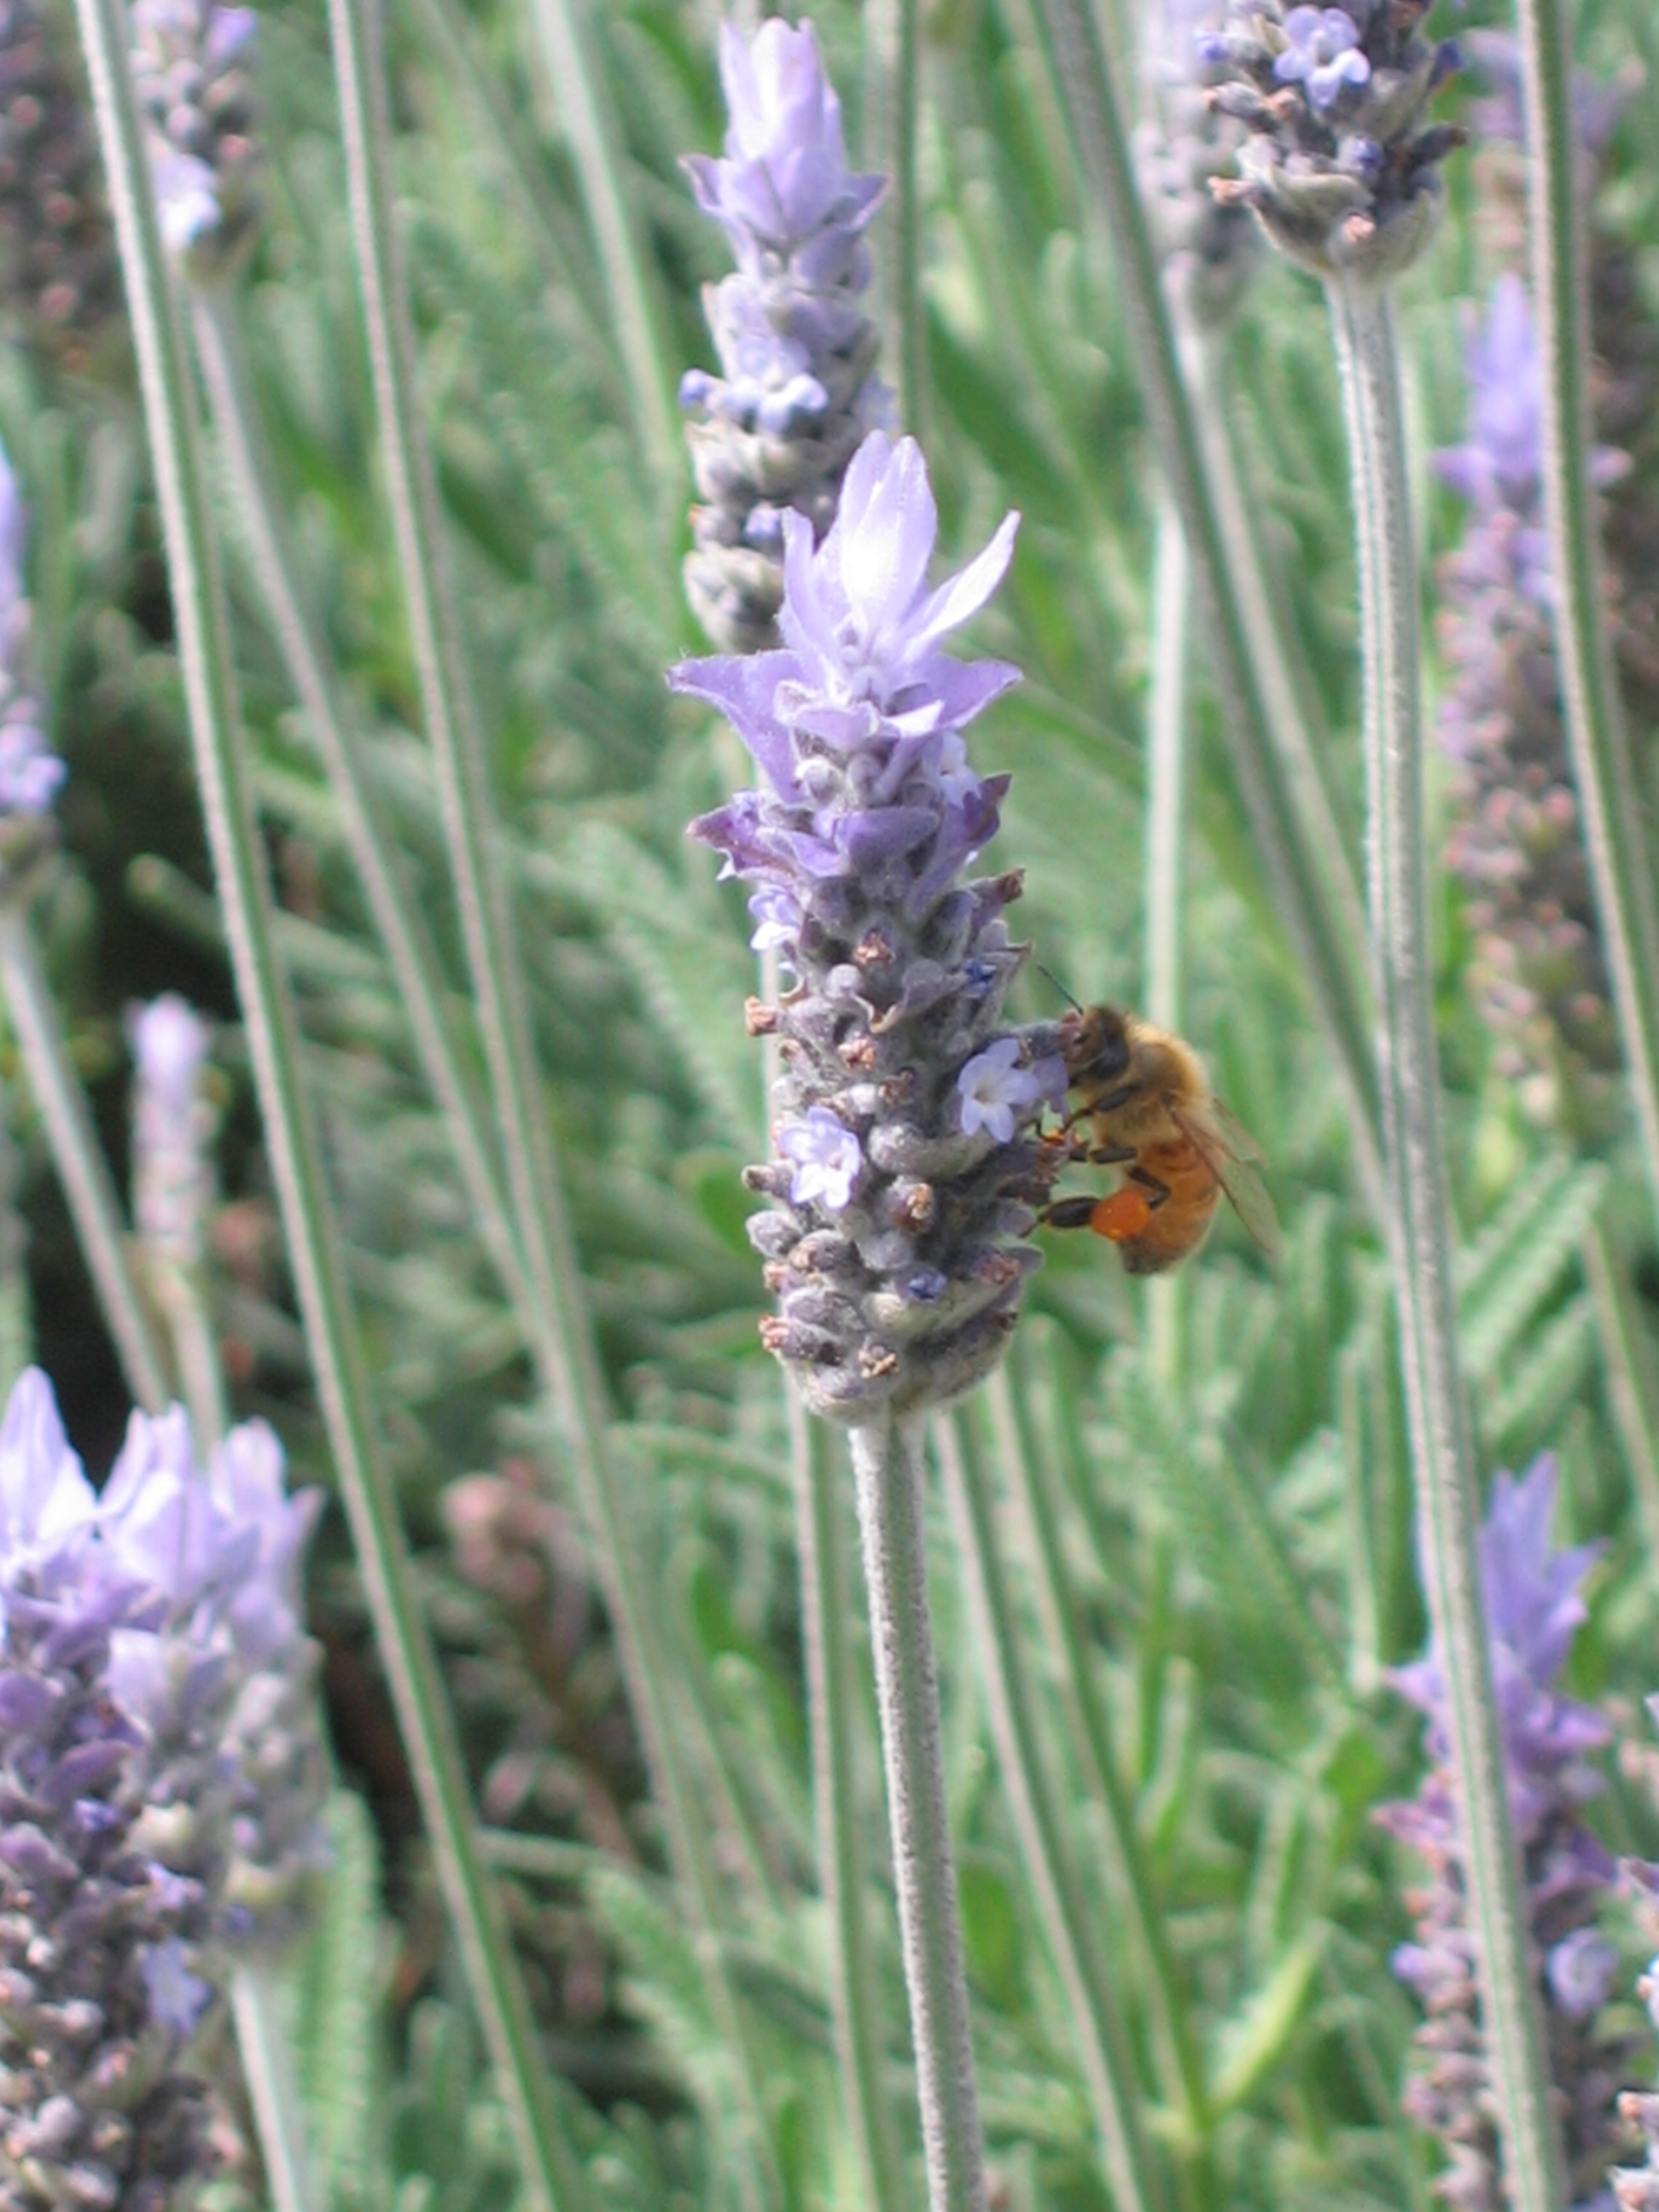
left=0, top=903, right=172, bottom=1413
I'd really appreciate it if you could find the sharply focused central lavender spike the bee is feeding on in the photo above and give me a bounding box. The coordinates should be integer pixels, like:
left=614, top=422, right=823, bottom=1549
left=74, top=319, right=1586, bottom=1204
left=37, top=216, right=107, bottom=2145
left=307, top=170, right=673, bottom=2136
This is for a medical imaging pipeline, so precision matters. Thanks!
left=668, top=431, right=1064, bottom=1423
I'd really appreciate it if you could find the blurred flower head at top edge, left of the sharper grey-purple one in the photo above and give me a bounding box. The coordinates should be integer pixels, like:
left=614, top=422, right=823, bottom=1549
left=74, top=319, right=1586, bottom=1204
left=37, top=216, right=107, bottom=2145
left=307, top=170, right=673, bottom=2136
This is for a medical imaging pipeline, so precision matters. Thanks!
left=1135, top=0, right=1256, bottom=329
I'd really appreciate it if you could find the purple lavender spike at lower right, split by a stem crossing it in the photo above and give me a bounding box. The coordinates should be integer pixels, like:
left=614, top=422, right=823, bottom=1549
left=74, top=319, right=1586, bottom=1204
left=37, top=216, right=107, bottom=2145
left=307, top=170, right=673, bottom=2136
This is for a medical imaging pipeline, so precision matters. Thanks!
left=1378, top=1453, right=1634, bottom=2212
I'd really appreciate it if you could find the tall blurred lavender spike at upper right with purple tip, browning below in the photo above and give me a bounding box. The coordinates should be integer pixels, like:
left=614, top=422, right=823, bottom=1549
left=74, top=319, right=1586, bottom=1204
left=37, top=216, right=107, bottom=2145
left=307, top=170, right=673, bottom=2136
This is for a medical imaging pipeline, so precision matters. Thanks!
left=1435, top=274, right=1619, bottom=1135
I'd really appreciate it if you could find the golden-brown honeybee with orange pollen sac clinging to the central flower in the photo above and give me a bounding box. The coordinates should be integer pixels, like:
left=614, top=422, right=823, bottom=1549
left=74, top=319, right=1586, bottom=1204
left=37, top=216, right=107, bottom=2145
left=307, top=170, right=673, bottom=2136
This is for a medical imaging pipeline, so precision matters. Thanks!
left=1044, top=1006, right=1278, bottom=1274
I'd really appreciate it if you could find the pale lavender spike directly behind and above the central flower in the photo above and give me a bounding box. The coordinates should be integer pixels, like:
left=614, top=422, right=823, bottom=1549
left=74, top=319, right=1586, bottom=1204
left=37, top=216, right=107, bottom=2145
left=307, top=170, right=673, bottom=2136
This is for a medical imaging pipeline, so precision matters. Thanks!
left=679, top=18, right=887, bottom=653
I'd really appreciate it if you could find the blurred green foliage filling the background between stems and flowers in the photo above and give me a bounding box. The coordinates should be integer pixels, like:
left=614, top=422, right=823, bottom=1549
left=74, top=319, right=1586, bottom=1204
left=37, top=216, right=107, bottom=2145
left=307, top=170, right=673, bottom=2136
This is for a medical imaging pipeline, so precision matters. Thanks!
left=0, top=0, right=1659, bottom=2212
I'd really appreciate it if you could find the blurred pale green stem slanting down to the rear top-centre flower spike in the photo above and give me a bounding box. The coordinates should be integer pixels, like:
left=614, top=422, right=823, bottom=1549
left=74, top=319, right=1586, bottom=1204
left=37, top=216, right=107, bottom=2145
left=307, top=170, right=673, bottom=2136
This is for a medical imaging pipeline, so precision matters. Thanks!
left=520, top=0, right=686, bottom=500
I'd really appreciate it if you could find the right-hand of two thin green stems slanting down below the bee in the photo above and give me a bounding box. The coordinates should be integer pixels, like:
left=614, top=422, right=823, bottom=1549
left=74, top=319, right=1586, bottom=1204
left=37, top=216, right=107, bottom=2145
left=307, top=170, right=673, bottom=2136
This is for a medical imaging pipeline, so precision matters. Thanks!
left=984, top=1369, right=1212, bottom=2168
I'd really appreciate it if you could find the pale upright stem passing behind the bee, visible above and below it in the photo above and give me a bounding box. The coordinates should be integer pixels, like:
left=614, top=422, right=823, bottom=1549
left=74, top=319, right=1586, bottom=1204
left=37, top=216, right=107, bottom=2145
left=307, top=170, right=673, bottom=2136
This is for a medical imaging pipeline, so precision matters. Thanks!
left=1144, top=491, right=1192, bottom=1391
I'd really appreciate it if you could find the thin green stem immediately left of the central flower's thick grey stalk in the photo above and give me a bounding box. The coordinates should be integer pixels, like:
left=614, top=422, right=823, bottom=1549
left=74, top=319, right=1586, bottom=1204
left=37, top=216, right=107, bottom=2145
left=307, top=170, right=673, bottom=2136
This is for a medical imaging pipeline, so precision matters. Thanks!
left=785, top=1385, right=907, bottom=2212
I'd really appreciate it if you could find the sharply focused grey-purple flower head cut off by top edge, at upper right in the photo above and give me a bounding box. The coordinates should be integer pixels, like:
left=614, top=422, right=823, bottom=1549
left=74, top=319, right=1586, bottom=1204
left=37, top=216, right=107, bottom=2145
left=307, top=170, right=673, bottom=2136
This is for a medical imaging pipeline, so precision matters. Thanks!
left=1201, top=0, right=1462, bottom=283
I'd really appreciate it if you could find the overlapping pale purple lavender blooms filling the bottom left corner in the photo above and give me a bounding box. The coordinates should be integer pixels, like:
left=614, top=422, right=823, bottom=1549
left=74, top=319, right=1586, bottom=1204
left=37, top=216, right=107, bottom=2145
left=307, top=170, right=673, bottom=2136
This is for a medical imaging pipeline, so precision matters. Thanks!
left=0, top=1369, right=318, bottom=2212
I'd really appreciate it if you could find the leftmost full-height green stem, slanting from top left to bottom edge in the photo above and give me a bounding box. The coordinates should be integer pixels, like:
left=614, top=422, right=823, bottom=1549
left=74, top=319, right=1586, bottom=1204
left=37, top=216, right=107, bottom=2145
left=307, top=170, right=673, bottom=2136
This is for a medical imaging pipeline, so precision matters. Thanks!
left=78, top=0, right=584, bottom=2212
